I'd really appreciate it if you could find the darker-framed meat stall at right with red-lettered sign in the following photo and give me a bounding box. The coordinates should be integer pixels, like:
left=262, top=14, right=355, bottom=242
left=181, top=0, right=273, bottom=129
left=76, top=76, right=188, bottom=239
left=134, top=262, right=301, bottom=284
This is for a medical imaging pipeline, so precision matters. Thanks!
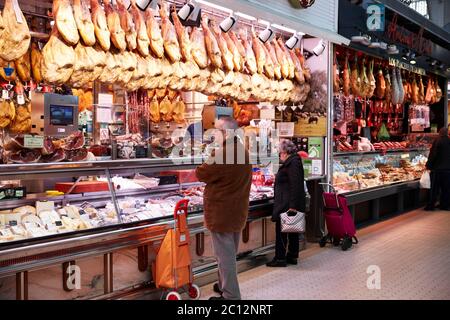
left=330, top=1, right=450, bottom=223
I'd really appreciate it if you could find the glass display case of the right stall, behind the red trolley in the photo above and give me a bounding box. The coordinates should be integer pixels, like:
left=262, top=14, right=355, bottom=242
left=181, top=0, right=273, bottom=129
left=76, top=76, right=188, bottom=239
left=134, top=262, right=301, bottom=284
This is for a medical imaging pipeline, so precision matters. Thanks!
left=333, top=149, right=429, bottom=193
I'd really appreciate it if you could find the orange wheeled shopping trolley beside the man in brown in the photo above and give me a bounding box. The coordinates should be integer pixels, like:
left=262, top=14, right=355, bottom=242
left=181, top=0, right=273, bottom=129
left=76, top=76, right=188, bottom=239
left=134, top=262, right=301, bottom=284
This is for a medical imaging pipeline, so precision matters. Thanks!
left=153, top=199, right=200, bottom=300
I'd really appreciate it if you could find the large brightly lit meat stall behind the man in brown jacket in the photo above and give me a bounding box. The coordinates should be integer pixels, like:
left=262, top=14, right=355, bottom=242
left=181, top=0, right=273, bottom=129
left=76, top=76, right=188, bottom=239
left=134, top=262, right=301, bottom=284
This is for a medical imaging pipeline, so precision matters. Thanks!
left=0, top=0, right=348, bottom=299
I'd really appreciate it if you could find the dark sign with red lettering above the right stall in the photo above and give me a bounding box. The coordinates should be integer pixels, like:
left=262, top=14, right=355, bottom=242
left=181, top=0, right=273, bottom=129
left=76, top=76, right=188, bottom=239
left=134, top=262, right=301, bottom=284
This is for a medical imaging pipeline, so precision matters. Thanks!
left=386, top=14, right=433, bottom=55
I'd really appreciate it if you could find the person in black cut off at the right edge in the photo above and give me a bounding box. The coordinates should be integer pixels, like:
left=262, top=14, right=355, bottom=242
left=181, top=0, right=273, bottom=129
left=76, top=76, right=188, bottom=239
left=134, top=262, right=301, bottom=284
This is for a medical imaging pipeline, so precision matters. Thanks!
left=425, top=128, right=450, bottom=211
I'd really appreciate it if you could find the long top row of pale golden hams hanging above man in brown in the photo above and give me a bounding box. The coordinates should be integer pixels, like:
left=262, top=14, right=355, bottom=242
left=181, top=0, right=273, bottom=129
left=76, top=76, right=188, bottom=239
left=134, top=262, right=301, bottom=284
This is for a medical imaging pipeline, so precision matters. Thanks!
left=29, top=0, right=311, bottom=102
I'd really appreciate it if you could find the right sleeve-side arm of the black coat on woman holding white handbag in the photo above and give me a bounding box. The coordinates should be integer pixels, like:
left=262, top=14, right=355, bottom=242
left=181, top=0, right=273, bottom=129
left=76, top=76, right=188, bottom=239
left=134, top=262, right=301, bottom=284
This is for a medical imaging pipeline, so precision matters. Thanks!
left=288, top=157, right=306, bottom=212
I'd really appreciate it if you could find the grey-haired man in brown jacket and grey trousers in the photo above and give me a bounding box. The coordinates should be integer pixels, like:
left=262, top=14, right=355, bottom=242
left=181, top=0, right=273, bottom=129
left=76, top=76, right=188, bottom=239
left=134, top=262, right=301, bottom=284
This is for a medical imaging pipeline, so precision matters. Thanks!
left=196, top=117, right=252, bottom=300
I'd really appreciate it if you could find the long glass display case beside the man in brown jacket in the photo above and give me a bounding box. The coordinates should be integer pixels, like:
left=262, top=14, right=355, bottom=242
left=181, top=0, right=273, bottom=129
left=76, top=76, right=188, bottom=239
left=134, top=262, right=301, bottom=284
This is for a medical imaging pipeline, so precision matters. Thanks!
left=0, top=159, right=273, bottom=246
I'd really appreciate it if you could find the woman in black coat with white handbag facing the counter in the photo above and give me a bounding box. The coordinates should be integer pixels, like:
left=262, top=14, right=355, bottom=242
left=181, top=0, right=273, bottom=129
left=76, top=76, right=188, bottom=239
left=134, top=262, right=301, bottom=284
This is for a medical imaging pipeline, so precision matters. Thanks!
left=267, top=140, right=305, bottom=267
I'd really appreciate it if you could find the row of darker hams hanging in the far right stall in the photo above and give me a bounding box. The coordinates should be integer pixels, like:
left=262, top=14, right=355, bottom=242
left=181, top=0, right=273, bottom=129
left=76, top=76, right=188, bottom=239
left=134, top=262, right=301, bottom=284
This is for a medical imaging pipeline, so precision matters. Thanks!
left=333, top=56, right=442, bottom=105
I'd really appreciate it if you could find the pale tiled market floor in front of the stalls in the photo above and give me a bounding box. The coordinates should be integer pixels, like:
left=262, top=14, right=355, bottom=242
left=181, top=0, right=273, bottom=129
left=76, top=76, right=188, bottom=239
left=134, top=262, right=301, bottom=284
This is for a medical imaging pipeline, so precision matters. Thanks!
left=202, top=211, right=450, bottom=300
